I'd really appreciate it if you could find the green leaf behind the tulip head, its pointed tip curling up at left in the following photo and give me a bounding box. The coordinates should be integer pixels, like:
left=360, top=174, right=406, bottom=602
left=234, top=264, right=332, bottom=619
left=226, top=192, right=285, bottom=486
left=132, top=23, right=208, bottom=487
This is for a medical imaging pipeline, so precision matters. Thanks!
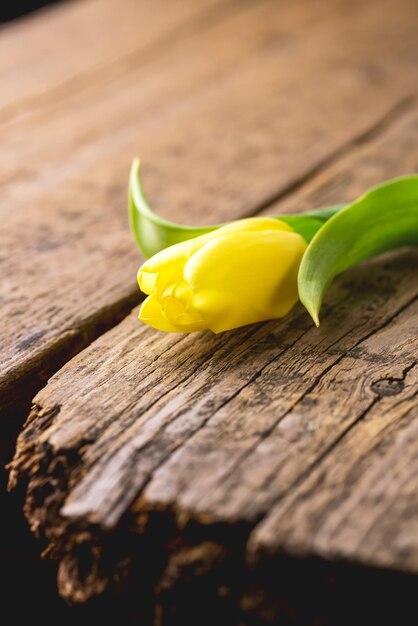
left=129, top=159, right=343, bottom=258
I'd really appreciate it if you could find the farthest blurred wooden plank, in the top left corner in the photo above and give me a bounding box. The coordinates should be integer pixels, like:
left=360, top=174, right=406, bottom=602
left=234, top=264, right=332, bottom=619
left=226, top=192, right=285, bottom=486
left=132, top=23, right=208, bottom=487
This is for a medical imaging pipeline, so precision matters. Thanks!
left=0, top=0, right=223, bottom=123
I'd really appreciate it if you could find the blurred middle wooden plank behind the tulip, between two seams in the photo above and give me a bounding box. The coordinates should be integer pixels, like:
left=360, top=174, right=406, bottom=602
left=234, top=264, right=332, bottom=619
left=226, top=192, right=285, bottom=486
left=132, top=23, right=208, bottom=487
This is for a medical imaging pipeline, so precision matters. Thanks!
left=0, top=0, right=416, bottom=420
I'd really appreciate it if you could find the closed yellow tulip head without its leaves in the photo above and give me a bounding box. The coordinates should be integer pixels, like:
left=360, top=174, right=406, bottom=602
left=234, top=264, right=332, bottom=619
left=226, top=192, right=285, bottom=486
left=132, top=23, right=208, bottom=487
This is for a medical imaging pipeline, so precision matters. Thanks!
left=138, top=217, right=307, bottom=333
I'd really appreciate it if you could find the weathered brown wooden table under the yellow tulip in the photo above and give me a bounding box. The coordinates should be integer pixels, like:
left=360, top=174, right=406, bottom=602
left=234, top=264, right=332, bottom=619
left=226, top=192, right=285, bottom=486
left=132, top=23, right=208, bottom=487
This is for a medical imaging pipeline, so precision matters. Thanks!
left=0, top=0, right=418, bottom=626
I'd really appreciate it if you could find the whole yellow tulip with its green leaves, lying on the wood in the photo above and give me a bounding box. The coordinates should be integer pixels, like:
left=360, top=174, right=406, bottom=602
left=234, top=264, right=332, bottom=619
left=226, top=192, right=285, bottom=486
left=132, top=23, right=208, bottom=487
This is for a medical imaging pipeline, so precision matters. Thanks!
left=129, top=159, right=418, bottom=326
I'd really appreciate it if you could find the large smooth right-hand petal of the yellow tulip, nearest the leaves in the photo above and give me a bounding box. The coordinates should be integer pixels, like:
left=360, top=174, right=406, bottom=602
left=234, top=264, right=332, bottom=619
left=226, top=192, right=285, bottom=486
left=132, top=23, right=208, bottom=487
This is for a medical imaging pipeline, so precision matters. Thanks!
left=184, top=225, right=306, bottom=332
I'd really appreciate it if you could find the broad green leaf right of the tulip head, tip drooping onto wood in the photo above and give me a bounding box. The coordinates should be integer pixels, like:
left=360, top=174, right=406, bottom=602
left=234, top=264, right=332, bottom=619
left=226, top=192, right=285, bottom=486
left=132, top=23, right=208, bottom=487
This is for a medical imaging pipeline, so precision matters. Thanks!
left=298, top=176, right=418, bottom=326
